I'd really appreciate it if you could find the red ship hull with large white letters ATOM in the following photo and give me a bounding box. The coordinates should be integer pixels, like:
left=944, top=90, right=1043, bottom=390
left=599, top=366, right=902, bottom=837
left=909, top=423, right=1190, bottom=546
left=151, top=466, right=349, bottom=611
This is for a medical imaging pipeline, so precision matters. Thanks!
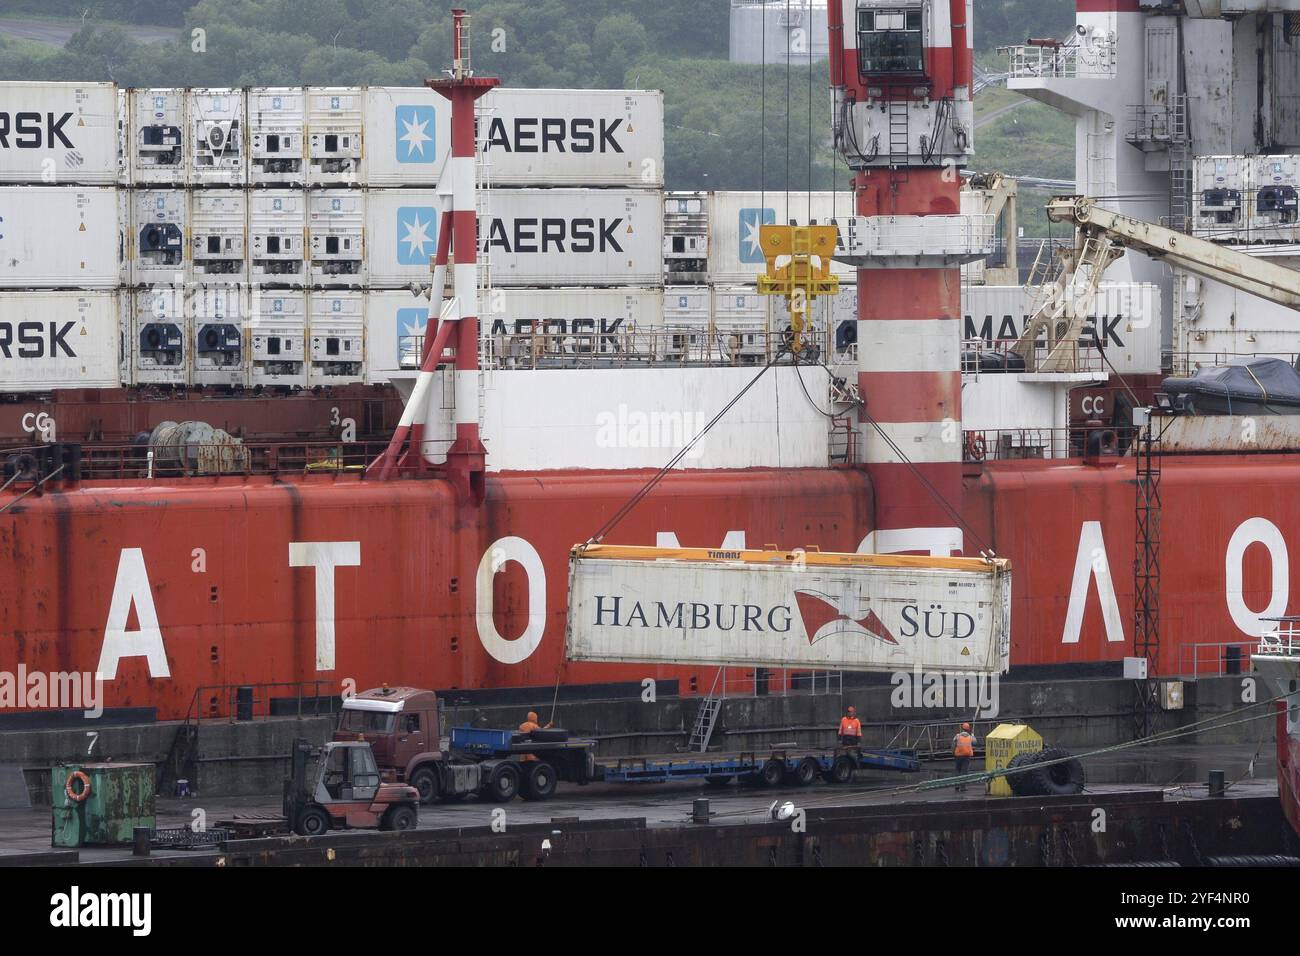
left=0, top=455, right=1300, bottom=719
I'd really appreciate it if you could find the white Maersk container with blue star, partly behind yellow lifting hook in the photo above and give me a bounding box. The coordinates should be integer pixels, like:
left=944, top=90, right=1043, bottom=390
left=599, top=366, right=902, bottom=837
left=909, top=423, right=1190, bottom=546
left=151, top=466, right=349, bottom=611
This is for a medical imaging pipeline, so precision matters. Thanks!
left=709, top=190, right=857, bottom=285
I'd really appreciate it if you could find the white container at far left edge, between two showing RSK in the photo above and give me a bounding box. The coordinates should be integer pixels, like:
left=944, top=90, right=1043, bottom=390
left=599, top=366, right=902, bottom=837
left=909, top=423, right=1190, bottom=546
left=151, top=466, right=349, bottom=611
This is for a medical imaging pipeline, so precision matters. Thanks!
left=0, top=186, right=122, bottom=289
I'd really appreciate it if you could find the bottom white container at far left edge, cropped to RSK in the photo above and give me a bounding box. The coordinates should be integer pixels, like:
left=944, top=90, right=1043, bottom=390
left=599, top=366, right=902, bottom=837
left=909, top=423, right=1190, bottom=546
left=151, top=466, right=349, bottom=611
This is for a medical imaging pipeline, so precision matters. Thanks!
left=0, top=291, right=121, bottom=392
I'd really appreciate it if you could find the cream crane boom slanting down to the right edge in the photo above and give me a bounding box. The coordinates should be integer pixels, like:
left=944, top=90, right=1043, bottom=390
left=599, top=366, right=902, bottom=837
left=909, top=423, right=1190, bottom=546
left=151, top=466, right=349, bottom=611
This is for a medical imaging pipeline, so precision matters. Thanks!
left=1048, top=196, right=1300, bottom=310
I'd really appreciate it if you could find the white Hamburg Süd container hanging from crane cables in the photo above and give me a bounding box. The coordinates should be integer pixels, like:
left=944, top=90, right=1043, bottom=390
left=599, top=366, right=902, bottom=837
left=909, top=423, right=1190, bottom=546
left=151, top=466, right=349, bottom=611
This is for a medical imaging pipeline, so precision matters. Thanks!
left=566, top=545, right=1011, bottom=674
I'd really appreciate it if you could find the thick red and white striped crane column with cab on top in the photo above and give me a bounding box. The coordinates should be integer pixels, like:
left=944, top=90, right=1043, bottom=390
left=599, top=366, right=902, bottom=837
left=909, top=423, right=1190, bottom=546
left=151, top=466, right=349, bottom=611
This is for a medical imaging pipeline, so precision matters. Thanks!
left=828, top=0, right=992, bottom=554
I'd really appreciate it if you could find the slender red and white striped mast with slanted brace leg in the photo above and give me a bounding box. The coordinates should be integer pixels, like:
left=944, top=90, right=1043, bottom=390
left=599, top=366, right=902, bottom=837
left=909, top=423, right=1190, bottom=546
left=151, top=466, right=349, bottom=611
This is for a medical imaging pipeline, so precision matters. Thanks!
left=372, top=9, right=501, bottom=503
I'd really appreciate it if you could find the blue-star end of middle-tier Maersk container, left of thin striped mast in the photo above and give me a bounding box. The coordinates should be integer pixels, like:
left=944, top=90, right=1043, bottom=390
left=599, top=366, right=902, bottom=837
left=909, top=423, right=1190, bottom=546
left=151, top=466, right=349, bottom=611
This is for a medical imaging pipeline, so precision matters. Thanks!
left=365, top=189, right=441, bottom=287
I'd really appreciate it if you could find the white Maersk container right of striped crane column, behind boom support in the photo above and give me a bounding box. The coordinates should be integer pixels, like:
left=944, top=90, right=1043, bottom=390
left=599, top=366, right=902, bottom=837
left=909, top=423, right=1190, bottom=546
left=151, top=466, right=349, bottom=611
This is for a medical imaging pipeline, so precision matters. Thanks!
left=962, top=282, right=1161, bottom=375
